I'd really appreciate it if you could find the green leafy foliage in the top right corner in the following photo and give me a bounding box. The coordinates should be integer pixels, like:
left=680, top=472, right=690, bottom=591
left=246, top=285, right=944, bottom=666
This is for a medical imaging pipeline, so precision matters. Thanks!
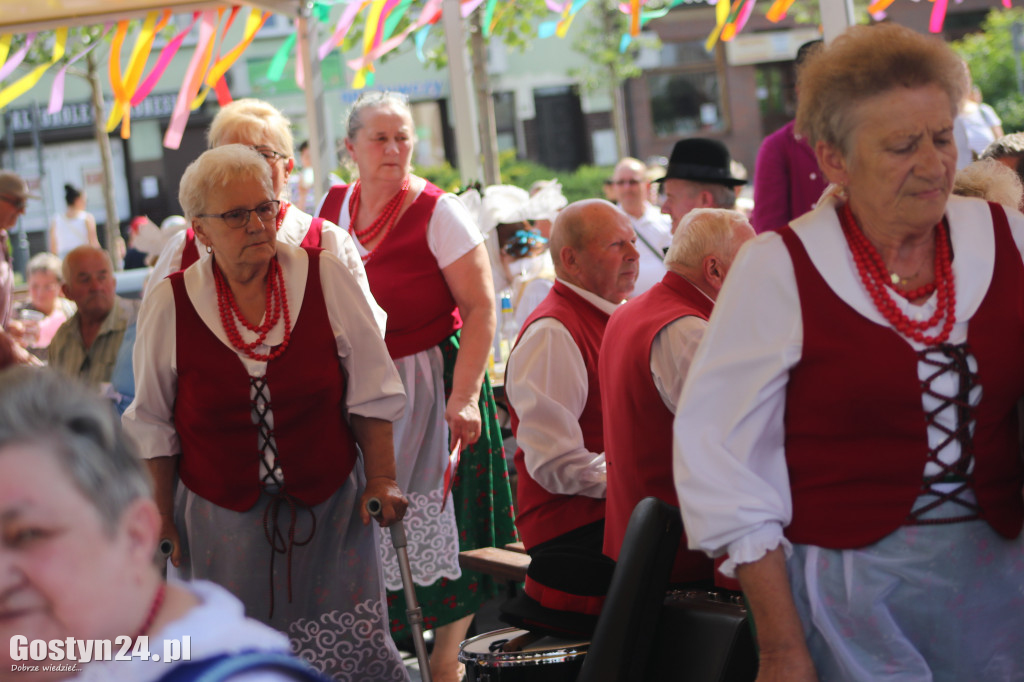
left=951, top=8, right=1024, bottom=133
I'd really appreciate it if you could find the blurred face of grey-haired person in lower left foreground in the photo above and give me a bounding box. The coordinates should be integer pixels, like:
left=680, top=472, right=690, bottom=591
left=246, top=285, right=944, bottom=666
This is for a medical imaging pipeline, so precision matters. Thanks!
left=0, top=442, right=141, bottom=659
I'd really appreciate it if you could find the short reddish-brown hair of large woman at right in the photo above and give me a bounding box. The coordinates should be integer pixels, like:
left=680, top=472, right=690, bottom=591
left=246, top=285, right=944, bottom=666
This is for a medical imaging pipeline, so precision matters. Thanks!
left=797, top=24, right=966, bottom=154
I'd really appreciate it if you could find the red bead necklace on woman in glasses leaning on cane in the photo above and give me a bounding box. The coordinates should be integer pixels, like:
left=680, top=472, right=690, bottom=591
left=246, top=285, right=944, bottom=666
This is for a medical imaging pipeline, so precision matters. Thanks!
left=212, top=256, right=292, bottom=363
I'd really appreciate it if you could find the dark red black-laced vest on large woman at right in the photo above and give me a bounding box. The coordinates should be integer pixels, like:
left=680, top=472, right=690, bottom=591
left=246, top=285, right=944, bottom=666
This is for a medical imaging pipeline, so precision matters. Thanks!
left=779, top=204, right=1024, bottom=549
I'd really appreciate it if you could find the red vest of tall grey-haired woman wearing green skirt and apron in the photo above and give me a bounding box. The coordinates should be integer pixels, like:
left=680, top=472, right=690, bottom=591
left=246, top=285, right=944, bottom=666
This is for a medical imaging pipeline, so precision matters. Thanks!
left=319, top=182, right=462, bottom=358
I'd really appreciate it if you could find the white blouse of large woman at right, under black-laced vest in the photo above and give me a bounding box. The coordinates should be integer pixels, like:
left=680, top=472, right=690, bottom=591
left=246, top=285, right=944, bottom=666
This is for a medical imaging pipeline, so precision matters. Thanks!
left=674, top=197, right=1024, bottom=576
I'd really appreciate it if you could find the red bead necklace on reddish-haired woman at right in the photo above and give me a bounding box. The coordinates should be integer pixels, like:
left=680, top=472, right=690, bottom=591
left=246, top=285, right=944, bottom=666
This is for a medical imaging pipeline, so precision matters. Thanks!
left=839, top=199, right=956, bottom=345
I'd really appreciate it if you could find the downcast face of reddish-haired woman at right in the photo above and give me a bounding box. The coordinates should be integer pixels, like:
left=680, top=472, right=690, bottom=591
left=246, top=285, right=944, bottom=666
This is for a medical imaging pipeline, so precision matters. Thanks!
left=823, top=85, right=956, bottom=233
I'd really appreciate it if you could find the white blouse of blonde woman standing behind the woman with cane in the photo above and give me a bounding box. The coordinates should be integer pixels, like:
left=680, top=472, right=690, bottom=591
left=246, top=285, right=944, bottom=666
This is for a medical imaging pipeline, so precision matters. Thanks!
left=143, top=204, right=387, bottom=337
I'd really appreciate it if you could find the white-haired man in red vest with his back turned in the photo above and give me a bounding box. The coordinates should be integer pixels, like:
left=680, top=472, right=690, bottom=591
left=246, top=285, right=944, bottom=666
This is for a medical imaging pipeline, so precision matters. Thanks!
left=599, top=209, right=755, bottom=589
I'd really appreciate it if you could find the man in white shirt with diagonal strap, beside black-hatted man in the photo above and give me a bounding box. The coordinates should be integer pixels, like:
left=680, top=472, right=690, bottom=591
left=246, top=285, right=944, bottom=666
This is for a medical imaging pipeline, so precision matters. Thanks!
left=611, top=158, right=672, bottom=297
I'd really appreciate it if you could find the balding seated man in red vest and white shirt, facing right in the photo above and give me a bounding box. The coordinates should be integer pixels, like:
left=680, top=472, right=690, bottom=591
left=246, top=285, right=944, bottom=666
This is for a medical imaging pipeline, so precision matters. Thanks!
left=503, top=199, right=634, bottom=636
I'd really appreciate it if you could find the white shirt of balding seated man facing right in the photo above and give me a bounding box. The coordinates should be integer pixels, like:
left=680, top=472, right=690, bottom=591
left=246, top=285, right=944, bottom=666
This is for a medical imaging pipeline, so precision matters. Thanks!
left=505, top=280, right=620, bottom=498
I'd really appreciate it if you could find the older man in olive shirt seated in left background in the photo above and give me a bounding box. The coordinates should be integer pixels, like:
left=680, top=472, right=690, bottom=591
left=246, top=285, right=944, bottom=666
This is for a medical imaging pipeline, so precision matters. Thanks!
left=49, top=246, right=138, bottom=387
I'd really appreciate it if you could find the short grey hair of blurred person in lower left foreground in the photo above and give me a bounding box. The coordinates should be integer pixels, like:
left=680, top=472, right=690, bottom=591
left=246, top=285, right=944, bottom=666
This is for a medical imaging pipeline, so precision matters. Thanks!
left=0, top=367, right=153, bottom=535
